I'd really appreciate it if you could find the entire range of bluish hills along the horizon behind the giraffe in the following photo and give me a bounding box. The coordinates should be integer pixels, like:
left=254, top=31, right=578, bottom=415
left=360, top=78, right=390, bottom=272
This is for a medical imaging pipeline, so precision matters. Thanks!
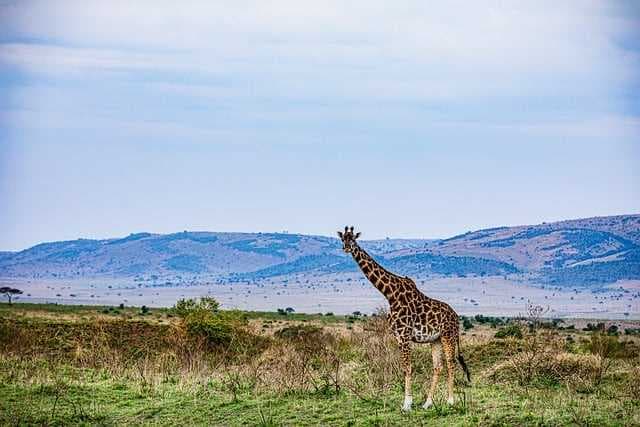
left=0, top=215, right=640, bottom=285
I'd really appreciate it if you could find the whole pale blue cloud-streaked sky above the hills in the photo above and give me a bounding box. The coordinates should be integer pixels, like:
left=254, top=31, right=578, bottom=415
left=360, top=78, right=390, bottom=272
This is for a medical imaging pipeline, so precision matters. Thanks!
left=0, top=0, right=640, bottom=250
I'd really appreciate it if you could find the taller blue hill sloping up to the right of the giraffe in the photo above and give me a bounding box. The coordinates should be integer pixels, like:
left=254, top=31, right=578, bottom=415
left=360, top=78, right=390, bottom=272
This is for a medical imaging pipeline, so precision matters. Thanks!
left=386, top=215, right=640, bottom=285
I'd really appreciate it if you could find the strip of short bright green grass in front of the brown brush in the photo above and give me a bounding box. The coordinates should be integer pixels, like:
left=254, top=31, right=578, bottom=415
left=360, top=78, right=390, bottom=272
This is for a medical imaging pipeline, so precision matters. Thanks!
left=0, top=361, right=640, bottom=426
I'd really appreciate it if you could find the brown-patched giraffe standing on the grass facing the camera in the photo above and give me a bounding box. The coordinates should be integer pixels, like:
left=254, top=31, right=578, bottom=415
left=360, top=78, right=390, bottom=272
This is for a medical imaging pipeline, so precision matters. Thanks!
left=338, top=227, right=471, bottom=411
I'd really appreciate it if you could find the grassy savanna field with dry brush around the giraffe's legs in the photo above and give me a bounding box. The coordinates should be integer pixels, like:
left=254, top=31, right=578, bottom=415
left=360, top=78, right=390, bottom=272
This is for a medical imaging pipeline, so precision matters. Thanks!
left=0, top=304, right=640, bottom=426
